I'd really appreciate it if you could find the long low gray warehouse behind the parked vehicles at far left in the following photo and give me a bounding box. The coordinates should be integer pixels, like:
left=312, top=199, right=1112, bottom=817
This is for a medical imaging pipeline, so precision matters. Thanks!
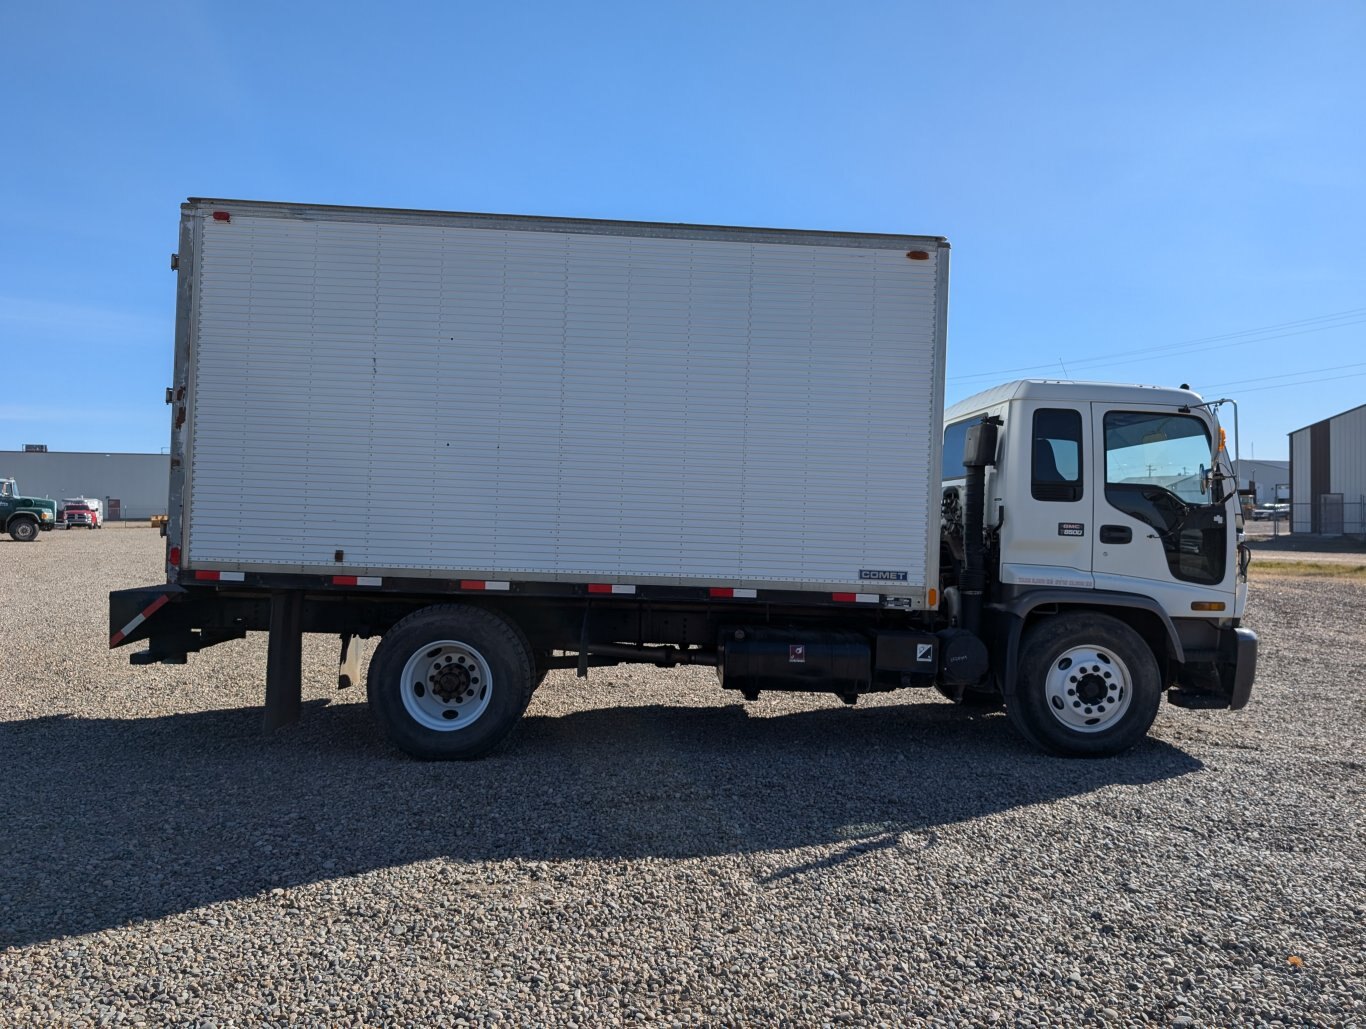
left=0, top=450, right=171, bottom=521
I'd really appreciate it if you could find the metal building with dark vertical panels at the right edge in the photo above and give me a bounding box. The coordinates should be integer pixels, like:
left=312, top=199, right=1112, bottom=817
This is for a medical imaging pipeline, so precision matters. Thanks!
left=1290, top=403, right=1366, bottom=536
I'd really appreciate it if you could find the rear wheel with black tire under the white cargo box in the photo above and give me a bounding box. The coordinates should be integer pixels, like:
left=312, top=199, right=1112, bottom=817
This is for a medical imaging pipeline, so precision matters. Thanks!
left=366, top=604, right=535, bottom=761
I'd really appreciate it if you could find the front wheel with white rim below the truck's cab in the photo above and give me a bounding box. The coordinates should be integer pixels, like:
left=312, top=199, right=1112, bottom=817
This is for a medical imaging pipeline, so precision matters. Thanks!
left=1005, top=614, right=1162, bottom=757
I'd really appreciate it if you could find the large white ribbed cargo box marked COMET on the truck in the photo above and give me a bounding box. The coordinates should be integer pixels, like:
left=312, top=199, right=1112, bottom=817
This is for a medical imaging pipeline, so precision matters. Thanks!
left=171, top=200, right=948, bottom=607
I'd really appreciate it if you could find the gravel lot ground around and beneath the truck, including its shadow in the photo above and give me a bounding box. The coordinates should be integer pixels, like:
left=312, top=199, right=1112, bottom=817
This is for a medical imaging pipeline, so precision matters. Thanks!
left=0, top=530, right=1366, bottom=1026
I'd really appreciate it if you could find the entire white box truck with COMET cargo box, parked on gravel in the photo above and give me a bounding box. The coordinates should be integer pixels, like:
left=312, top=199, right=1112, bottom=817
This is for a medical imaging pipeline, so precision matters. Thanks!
left=111, top=200, right=1257, bottom=758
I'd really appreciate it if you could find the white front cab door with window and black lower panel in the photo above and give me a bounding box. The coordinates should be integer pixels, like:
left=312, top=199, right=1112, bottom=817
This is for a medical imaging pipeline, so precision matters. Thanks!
left=1091, top=403, right=1229, bottom=593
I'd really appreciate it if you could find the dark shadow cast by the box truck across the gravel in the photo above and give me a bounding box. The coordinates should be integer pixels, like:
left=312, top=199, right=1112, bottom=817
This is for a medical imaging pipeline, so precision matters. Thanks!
left=0, top=701, right=1202, bottom=948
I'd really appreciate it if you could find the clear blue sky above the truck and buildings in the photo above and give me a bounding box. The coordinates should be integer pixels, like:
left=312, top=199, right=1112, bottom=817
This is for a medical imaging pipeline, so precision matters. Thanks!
left=0, top=0, right=1366, bottom=458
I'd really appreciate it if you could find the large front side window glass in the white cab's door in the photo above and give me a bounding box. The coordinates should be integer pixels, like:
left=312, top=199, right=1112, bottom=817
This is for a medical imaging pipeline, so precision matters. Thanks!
left=1105, top=411, right=1210, bottom=504
